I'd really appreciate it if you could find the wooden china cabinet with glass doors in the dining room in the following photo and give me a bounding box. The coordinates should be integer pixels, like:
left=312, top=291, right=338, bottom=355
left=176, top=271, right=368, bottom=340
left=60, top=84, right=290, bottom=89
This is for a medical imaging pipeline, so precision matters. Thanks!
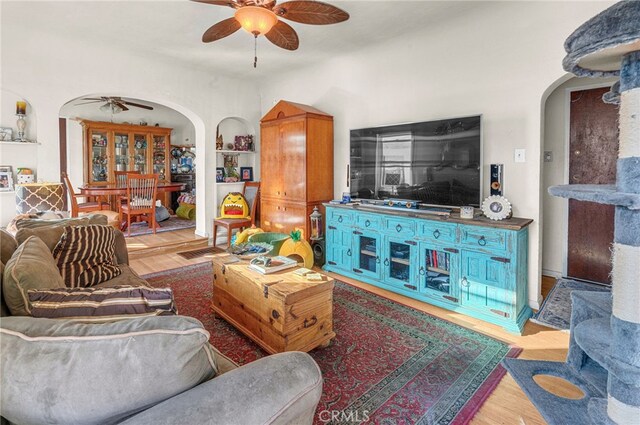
left=80, top=120, right=172, bottom=206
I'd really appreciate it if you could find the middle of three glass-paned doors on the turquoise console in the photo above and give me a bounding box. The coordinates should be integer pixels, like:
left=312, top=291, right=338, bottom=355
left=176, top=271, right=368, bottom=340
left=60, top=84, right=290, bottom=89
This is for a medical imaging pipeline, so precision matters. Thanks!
left=383, top=238, right=418, bottom=291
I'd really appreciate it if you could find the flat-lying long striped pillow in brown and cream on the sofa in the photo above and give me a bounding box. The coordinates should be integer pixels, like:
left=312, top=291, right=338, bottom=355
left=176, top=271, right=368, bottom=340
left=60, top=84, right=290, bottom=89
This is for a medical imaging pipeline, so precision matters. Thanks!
left=28, top=285, right=178, bottom=322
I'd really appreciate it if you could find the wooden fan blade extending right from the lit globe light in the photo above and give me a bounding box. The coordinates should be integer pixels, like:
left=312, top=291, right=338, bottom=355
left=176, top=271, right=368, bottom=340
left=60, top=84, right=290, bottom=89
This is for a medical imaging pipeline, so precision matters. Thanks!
left=273, top=0, right=349, bottom=25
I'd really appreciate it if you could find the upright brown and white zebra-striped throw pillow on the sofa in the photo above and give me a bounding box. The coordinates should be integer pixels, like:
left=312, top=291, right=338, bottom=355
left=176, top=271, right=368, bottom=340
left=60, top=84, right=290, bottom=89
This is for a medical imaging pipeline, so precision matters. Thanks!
left=53, top=225, right=121, bottom=288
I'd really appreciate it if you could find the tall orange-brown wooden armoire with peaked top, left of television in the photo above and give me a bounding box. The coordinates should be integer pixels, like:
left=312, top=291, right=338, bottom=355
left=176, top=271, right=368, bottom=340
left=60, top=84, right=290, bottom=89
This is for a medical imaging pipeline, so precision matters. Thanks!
left=260, top=100, right=333, bottom=239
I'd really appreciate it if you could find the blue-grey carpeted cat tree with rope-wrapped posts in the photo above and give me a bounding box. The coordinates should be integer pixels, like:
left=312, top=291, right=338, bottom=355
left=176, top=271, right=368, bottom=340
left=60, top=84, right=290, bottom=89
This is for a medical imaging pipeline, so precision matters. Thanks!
left=503, top=1, right=640, bottom=425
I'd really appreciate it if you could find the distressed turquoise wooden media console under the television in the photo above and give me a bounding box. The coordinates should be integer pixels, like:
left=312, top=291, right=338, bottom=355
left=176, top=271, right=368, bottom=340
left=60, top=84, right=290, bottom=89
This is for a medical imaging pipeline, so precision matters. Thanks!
left=324, top=204, right=532, bottom=333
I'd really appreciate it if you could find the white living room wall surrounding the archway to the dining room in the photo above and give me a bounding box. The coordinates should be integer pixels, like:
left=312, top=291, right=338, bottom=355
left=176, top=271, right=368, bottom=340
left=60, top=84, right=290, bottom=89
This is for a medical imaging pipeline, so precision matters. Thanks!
left=0, top=17, right=260, bottom=235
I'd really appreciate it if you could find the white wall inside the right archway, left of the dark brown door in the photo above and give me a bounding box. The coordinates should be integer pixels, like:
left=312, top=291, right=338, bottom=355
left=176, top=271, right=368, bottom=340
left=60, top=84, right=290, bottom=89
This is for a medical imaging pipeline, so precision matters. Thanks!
left=542, top=78, right=617, bottom=277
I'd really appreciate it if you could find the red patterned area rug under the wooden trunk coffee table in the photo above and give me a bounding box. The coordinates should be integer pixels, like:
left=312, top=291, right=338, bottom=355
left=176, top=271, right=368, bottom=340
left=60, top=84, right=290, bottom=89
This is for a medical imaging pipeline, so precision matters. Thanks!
left=145, top=263, right=520, bottom=425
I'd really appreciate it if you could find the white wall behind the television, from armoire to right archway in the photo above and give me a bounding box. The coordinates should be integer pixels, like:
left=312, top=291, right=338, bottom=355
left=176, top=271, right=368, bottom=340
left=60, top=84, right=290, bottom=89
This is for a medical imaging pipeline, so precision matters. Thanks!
left=260, top=2, right=612, bottom=307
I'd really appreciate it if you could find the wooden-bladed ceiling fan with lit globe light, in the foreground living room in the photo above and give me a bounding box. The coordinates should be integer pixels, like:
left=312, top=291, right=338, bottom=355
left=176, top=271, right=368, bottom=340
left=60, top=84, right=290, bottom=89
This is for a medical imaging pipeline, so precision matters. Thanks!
left=192, top=0, right=349, bottom=68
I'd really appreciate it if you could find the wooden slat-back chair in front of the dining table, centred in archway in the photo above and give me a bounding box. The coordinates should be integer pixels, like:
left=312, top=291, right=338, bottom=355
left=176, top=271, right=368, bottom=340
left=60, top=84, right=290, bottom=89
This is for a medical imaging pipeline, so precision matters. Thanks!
left=119, top=174, right=158, bottom=236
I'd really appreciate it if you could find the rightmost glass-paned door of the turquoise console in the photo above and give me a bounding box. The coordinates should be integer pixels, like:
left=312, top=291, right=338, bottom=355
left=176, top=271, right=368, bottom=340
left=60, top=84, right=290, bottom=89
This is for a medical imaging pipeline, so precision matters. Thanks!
left=418, top=245, right=459, bottom=302
